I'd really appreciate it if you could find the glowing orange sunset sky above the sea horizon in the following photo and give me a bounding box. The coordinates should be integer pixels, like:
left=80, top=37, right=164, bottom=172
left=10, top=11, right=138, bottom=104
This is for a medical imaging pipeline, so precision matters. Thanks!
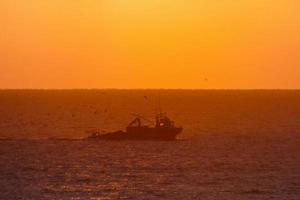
left=0, top=0, right=300, bottom=89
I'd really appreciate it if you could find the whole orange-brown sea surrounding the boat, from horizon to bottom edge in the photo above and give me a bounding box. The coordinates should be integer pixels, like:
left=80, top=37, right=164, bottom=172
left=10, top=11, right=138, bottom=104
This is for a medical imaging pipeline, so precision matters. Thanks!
left=0, top=89, right=300, bottom=200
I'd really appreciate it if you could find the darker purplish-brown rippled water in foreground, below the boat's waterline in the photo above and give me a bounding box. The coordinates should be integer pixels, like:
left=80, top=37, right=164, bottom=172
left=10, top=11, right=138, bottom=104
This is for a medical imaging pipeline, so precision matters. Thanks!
left=0, top=136, right=300, bottom=200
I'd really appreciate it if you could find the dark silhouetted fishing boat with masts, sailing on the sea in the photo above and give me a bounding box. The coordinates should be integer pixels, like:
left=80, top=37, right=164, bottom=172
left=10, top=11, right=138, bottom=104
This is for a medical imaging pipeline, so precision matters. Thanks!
left=87, top=113, right=182, bottom=141
